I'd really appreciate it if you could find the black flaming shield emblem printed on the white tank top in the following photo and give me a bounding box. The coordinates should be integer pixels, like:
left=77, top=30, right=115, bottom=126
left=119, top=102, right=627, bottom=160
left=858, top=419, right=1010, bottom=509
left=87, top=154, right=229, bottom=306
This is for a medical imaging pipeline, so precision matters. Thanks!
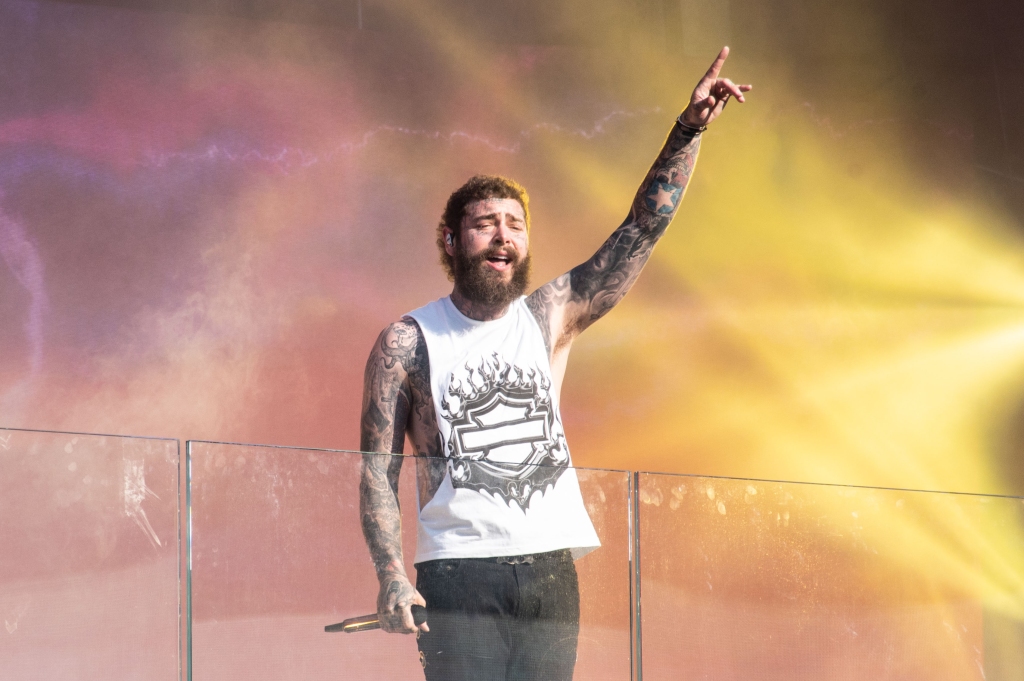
left=441, top=354, right=569, bottom=508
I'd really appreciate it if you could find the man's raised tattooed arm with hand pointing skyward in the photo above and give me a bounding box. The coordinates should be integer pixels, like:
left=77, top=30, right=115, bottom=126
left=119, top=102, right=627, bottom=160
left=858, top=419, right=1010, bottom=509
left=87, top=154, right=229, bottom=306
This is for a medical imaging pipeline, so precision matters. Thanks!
left=527, top=47, right=751, bottom=354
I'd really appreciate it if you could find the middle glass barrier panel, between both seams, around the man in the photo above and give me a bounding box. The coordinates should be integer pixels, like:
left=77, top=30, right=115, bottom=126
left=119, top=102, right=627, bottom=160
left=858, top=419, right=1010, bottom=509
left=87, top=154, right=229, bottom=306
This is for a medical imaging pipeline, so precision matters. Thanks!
left=188, top=441, right=631, bottom=681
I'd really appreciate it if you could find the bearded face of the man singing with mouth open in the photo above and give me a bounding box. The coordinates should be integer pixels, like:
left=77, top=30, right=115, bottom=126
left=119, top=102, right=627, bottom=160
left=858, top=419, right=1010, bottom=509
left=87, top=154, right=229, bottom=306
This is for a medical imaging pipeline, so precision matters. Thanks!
left=447, top=199, right=529, bottom=305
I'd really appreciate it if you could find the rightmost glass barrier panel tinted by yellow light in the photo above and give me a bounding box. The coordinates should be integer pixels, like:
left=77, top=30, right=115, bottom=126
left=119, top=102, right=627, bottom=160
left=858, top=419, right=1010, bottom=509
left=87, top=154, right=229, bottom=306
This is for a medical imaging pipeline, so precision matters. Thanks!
left=638, top=473, right=1024, bottom=681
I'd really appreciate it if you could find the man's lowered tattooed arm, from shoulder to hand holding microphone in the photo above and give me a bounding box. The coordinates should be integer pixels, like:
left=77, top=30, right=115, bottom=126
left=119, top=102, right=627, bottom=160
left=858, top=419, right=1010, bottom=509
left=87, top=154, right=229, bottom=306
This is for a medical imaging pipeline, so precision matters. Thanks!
left=359, top=321, right=429, bottom=634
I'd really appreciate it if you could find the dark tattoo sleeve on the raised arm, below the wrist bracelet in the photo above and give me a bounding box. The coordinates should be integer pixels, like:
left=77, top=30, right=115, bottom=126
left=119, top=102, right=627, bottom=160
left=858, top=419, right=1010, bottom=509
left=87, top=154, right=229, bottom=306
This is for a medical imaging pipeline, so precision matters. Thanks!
left=569, top=125, right=700, bottom=331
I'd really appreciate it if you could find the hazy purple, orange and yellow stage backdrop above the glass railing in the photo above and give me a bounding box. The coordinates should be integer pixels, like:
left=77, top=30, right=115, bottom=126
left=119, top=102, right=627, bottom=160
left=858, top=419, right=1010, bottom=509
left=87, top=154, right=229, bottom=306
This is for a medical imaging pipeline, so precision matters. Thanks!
left=0, top=0, right=1024, bottom=494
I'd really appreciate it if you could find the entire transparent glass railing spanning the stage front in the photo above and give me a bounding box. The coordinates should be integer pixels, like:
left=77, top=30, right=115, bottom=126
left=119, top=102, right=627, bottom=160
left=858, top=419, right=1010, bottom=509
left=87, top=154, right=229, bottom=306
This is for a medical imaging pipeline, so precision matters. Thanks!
left=0, top=430, right=1024, bottom=681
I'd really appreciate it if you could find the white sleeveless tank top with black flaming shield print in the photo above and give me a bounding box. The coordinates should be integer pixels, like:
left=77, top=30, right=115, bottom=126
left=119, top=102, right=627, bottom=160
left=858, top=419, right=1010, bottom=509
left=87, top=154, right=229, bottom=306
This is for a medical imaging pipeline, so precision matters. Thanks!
left=408, top=297, right=600, bottom=562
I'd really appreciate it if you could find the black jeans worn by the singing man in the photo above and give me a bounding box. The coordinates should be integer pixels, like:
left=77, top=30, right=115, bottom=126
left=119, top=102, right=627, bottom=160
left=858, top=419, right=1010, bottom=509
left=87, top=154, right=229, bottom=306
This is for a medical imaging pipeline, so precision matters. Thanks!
left=416, top=551, right=580, bottom=681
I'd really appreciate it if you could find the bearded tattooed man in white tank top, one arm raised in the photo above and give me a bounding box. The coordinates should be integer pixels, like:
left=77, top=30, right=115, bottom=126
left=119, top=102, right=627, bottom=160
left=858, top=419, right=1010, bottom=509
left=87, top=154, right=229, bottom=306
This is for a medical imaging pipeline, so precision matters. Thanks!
left=360, top=47, right=751, bottom=681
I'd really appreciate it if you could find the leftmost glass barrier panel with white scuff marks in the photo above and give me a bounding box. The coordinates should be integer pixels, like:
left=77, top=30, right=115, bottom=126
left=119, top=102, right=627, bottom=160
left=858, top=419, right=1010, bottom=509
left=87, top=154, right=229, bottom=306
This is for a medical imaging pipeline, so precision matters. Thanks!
left=0, top=429, right=180, bottom=681
